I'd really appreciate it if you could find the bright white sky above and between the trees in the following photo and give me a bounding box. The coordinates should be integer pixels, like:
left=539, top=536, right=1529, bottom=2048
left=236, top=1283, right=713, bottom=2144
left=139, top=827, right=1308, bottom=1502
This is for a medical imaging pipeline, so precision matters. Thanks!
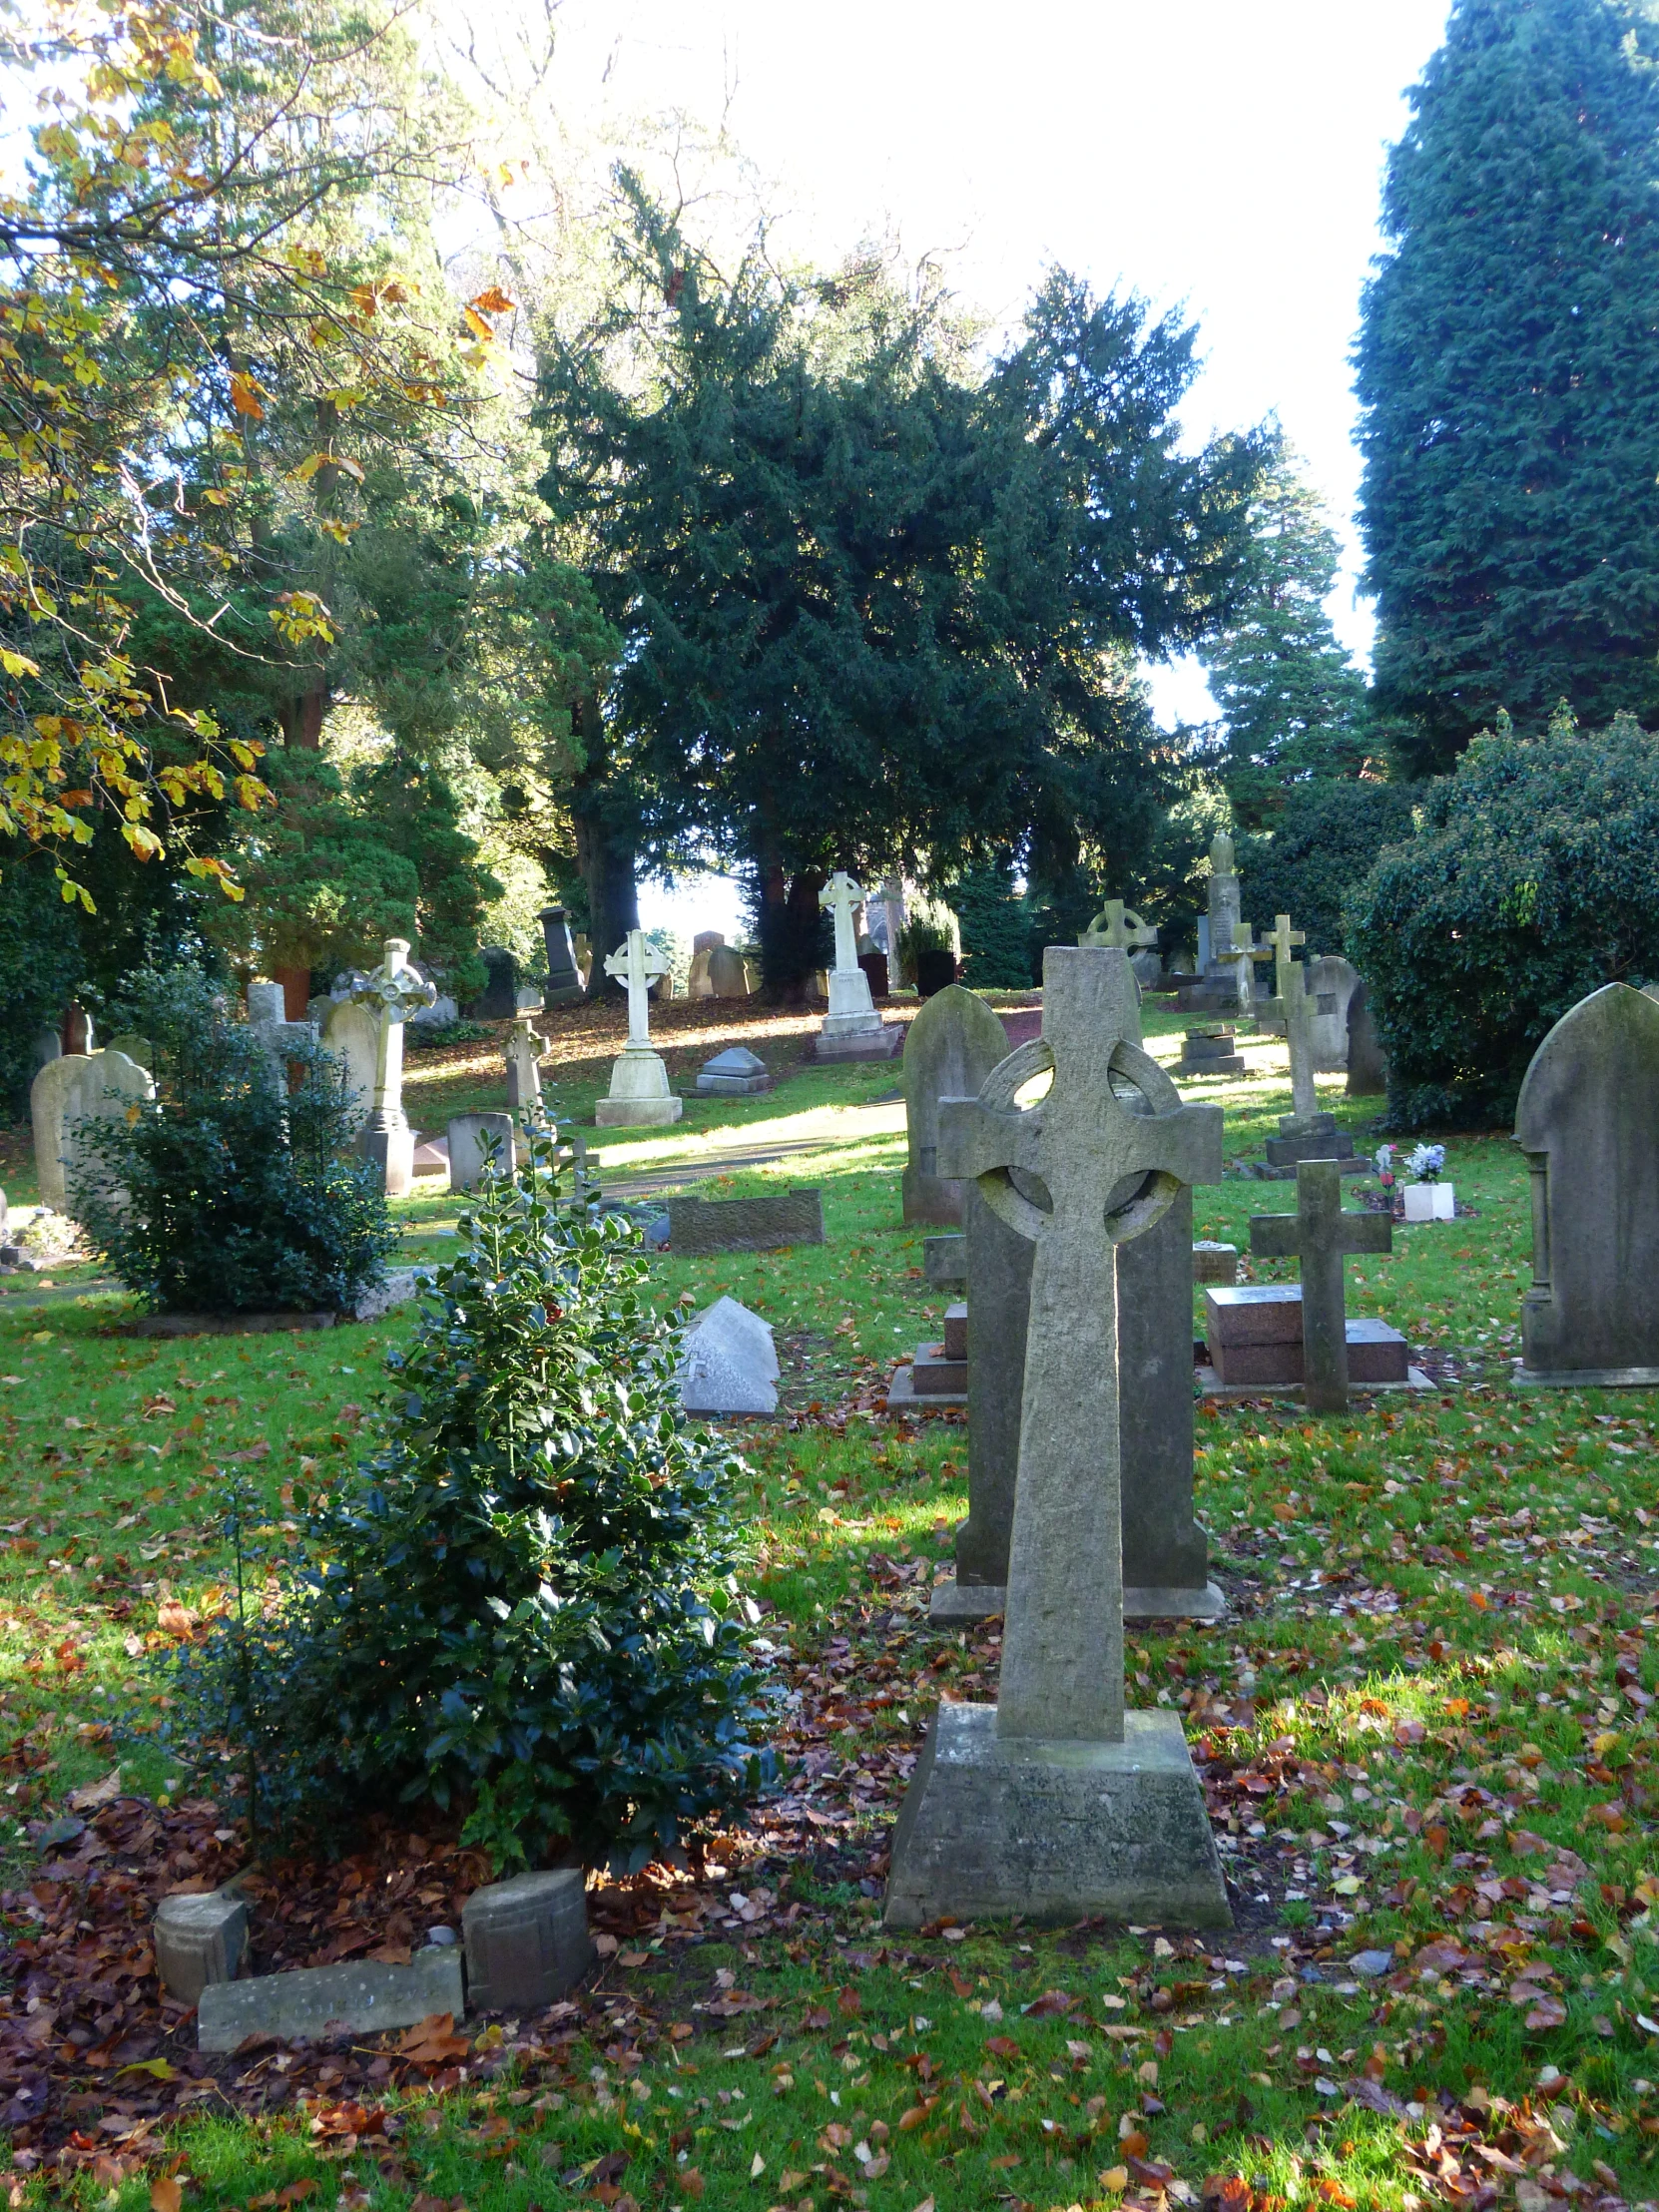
left=510, top=0, right=1446, bottom=933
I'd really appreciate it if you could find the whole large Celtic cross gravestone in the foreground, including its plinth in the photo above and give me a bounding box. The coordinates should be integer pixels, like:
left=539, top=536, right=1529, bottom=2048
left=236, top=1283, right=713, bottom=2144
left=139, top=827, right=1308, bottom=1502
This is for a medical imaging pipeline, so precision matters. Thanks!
left=887, top=946, right=1230, bottom=1927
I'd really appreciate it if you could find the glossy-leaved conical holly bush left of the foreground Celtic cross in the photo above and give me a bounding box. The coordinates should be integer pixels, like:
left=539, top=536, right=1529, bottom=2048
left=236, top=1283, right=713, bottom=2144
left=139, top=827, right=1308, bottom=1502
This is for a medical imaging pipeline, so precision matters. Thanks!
left=162, top=1135, right=770, bottom=1870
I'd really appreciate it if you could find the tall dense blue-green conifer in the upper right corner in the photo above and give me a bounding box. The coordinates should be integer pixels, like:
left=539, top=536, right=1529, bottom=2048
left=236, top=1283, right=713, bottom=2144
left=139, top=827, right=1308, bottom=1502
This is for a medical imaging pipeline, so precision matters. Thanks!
left=1356, top=0, right=1659, bottom=772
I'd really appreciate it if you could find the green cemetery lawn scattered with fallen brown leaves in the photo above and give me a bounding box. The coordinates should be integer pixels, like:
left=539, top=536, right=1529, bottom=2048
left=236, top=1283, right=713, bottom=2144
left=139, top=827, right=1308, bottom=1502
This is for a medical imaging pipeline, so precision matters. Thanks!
left=0, top=1006, right=1659, bottom=2212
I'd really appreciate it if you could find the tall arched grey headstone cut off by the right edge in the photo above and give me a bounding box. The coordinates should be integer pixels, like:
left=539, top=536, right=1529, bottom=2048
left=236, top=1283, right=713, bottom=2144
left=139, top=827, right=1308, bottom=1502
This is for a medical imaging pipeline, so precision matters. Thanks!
left=1515, top=982, right=1659, bottom=1389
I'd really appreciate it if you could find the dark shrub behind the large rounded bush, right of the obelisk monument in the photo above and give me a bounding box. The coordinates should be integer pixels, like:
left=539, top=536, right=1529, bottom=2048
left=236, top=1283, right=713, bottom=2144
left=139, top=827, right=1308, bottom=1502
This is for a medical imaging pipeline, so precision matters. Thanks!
left=1239, top=777, right=1424, bottom=953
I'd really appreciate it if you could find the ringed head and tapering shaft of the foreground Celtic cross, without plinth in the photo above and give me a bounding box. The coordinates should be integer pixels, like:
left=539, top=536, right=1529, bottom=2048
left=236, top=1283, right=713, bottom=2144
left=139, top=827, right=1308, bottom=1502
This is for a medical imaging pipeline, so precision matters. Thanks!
left=938, top=944, right=1221, bottom=1743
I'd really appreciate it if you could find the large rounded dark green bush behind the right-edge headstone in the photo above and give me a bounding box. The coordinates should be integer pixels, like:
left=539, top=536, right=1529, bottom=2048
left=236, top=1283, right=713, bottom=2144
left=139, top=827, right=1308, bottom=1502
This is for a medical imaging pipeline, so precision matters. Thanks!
left=1354, top=717, right=1659, bottom=1128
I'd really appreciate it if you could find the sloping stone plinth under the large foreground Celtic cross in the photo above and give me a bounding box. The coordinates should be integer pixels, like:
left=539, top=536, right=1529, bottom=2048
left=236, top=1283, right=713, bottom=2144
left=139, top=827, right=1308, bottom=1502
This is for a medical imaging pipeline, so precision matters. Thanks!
left=884, top=1706, right=1232, bottom=1929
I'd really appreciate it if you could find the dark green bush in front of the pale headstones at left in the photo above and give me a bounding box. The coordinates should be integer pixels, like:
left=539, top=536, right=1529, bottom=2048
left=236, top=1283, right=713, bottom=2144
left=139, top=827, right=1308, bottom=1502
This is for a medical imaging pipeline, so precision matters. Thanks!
left=71, top=969, right=396, bottom=1314
